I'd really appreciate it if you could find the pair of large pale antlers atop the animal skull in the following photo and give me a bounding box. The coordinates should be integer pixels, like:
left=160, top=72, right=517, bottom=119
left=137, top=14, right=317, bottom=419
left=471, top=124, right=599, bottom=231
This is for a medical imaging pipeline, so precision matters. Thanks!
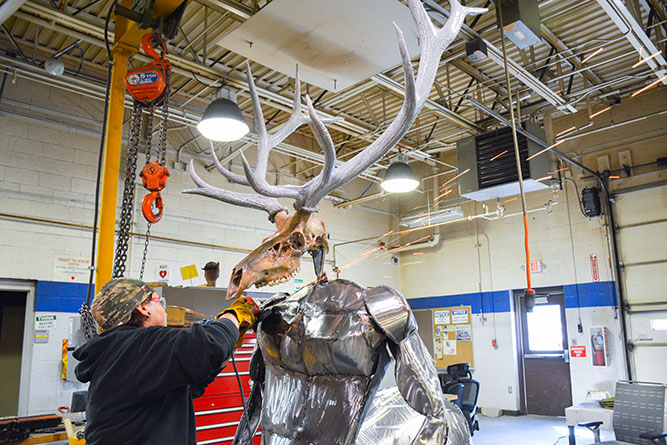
left=185, top=0, right=487, bottom=218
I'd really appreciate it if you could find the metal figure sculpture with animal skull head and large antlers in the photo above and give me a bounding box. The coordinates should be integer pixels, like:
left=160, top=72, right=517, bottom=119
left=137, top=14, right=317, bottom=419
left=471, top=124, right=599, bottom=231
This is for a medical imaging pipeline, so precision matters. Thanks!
left=184, top=0, right=486, bottom=445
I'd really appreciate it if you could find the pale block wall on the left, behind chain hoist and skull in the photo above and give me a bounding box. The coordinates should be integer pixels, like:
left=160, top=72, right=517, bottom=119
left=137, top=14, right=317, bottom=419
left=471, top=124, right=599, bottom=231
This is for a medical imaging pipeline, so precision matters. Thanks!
left=0, top=79, right=400, bottom=414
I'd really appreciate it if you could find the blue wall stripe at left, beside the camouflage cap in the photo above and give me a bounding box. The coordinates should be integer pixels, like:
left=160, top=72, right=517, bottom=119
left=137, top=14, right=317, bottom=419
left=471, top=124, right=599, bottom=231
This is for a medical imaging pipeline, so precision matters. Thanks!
left=35, top=281, right=95, bottom=312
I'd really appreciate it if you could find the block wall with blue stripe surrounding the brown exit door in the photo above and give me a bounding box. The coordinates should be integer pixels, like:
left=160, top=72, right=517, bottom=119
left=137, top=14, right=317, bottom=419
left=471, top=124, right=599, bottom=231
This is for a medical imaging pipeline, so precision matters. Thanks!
left=401, top=186, right=624, bottom=411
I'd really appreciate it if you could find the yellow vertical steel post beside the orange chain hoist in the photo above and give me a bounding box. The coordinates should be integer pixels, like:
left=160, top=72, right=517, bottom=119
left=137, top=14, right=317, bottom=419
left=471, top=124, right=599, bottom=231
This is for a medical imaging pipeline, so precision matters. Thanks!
left=95, top=0, right=183, bottom=293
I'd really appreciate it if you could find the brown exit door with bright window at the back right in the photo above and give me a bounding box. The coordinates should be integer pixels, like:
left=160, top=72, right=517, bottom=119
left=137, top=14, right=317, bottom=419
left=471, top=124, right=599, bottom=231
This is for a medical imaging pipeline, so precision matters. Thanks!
left=514, top=287, right=572, bottom=416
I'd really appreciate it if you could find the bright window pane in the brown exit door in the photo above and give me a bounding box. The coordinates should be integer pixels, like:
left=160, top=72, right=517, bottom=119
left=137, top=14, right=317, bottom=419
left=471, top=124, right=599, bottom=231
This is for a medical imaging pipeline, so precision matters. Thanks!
left=526, top=304, right=563, bottom=352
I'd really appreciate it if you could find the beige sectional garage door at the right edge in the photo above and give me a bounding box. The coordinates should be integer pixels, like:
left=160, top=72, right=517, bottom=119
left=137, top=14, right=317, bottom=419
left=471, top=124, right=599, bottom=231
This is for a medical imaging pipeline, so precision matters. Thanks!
left=615, top=182, right=667, bottom=382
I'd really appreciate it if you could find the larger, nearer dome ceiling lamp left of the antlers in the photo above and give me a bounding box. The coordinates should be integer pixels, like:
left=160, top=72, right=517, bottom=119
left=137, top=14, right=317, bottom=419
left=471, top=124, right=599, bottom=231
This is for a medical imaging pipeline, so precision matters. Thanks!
left=197, top=87, right=250, bottom=142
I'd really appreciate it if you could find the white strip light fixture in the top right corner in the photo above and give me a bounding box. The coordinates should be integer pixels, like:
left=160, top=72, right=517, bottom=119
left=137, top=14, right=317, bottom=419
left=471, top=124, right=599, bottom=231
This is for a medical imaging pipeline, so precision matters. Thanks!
left=597, top=0, right=667, bottom=85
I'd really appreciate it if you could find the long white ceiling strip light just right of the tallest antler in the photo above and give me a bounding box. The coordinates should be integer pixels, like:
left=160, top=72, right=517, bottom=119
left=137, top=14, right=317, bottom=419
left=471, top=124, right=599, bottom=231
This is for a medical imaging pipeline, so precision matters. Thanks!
left=424, top=0, right=576, bottom=113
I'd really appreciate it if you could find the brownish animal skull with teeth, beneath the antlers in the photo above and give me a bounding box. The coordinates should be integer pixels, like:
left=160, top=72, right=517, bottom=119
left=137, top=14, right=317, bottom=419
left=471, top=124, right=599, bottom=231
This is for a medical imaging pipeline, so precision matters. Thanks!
left=227, top=210, right=328, bottom=300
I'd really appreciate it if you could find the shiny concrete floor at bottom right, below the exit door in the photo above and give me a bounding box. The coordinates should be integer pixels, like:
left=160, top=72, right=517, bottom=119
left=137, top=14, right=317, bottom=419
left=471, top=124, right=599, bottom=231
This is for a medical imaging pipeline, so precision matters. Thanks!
left=472, top=415, right=614, bottom=445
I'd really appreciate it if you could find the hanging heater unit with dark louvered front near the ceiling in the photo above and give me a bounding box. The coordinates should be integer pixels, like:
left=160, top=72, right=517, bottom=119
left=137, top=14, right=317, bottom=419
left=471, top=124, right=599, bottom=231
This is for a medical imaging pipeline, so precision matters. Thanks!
left=456, top=125, right=550, bottom=201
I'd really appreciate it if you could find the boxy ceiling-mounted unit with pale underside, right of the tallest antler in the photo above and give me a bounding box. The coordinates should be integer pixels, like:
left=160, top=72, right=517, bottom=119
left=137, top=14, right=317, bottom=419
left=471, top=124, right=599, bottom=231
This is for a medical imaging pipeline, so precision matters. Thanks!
left=496, top=0, right=542, bottom=49
